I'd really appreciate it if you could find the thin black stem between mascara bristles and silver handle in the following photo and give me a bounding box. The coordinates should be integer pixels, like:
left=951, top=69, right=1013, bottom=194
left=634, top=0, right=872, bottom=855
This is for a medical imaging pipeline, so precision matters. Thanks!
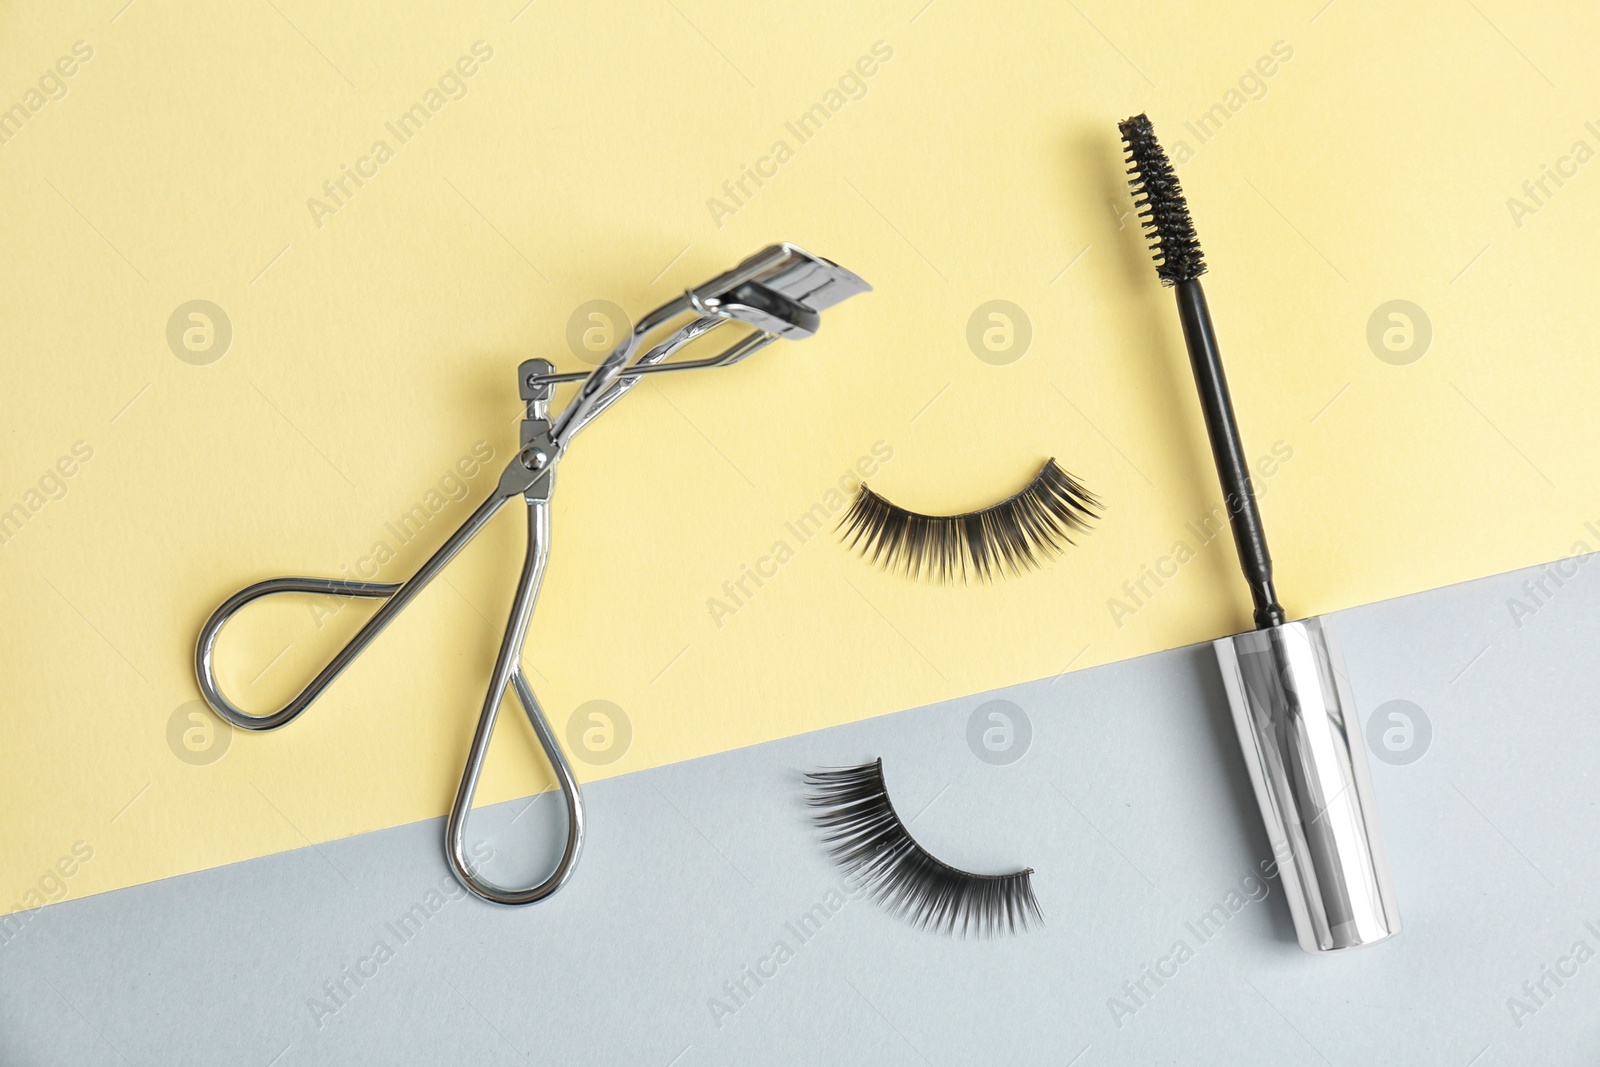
left=1176, top=280, right=1286, bottom=629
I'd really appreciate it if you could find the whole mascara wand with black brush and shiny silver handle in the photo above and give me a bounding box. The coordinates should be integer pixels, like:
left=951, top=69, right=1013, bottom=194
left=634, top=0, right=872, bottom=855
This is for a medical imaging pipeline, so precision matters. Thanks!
left=1118, top=115, right=1400, bottom=952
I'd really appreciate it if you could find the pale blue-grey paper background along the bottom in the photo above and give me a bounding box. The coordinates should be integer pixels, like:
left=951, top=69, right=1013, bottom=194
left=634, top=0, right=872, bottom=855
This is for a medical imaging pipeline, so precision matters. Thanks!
left=0, top=560, right=1600, bottom=1067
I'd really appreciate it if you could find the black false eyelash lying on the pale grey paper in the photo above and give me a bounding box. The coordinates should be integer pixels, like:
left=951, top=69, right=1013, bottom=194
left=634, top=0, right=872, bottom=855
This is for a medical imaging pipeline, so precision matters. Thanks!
left=806, top=760, right=1045, bottom=937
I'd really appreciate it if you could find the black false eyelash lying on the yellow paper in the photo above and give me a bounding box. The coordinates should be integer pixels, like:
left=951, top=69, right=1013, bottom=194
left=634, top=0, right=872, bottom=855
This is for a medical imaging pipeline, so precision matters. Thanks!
left=838, top=459, right=1101, bottom=582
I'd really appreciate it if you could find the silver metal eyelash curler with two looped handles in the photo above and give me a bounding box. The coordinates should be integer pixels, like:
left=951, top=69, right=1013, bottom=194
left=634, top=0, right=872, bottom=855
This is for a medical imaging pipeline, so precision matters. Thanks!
left=195, top=245, right=872, bottom=904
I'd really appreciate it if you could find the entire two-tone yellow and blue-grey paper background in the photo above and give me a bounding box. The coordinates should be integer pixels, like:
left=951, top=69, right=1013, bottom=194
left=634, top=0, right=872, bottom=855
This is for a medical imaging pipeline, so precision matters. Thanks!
left=0, top=0, right=1600, bottom=1064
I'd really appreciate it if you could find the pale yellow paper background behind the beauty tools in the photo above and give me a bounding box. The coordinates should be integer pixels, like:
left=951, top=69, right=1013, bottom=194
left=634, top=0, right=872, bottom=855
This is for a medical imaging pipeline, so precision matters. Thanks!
left=0, top=0, right=1600, bottom=910
